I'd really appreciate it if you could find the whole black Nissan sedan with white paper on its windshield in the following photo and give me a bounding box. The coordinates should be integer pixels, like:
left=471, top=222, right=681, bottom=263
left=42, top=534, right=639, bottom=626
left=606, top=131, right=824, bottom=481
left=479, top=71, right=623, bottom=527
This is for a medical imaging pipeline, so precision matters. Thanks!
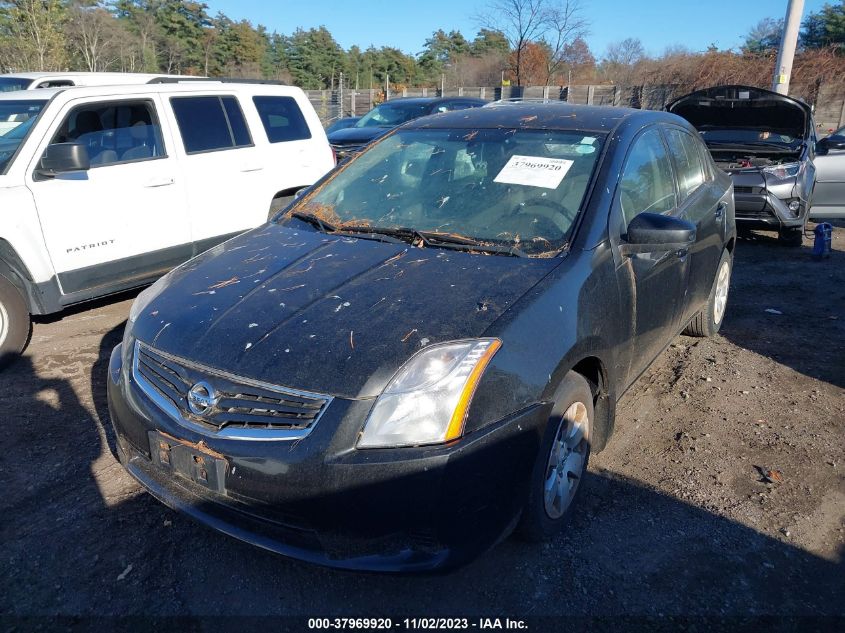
left=109, top=104, right=735, bottom=571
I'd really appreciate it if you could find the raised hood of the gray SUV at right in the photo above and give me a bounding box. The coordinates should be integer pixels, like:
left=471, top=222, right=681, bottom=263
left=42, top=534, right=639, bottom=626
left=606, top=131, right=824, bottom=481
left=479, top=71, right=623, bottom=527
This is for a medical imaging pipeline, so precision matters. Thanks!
left=666, top=85, right=812, bottom=139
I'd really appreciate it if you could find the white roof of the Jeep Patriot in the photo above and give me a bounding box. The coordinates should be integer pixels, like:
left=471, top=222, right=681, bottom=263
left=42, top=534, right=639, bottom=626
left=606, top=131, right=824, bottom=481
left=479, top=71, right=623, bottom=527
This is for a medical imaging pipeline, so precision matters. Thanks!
left=0, top=81, right=302, bottom=101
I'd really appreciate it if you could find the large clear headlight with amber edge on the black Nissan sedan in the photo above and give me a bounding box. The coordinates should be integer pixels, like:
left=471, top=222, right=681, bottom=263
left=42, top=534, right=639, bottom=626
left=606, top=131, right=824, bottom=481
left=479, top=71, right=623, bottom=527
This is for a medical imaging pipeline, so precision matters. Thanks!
left=358, top=339, right=502, bottom=448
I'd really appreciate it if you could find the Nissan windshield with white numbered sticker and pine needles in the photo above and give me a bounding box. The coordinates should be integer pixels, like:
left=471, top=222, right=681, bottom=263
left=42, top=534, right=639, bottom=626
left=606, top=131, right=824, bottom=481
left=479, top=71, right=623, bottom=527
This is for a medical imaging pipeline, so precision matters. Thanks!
left=290, top=129, right=603, bottom=256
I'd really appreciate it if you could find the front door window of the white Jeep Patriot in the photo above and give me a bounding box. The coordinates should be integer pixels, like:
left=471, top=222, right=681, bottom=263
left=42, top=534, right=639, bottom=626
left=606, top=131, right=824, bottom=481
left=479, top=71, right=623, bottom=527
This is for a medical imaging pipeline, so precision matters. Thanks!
left=51, top=101, right=166, bottom=167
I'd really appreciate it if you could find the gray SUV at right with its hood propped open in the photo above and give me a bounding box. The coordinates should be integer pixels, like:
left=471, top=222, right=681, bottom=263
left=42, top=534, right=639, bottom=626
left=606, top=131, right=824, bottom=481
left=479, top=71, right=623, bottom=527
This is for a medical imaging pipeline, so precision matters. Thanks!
left=666, top=85, right=816, bottom=246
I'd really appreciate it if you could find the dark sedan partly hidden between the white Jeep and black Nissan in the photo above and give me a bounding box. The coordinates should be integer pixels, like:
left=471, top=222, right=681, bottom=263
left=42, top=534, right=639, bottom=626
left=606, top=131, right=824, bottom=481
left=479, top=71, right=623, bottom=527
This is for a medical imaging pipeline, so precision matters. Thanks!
left=327, top=97, right=487, bottom=161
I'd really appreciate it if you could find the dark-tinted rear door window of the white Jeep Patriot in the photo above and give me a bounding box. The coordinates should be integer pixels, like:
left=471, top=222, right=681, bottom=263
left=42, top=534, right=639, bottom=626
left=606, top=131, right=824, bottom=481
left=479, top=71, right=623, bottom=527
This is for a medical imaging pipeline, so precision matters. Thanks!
left=170, top=96, right=252, bottom=154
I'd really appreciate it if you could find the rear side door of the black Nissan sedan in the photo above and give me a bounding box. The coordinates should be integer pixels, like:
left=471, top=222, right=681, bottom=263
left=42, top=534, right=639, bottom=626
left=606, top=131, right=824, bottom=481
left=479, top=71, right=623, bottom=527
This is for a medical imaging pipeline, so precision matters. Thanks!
left=663, top=126, right=728, bottom=322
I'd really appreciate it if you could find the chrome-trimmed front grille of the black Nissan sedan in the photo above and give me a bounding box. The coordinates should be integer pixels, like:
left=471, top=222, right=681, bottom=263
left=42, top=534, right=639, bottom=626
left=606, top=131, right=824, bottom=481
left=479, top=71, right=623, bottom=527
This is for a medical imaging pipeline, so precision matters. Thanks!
left=133, top=341, right=331, bottom=439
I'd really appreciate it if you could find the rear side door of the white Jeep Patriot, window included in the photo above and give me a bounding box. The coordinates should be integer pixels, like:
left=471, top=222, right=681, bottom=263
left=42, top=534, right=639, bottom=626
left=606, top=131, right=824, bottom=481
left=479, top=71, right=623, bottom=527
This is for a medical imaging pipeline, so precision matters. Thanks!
left=167, top=93, right=272, bottom=250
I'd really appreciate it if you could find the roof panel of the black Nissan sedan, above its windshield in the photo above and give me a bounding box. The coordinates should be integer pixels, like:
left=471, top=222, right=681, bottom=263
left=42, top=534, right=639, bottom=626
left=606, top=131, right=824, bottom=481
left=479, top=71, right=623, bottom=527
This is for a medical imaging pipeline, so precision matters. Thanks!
left=403, top=102, right=672, bottom=133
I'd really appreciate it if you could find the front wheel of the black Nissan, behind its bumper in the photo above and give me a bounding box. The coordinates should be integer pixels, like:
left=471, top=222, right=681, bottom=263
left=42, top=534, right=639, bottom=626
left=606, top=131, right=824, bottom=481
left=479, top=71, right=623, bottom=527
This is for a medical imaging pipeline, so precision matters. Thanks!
left=517, top=371, right=595, bottom=542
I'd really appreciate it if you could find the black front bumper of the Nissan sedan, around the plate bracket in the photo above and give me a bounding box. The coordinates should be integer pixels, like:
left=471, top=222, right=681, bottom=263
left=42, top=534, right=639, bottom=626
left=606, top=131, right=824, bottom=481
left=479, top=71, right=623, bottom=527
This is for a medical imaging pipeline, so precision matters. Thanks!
left=108, top=346, right=549, bottom=572
